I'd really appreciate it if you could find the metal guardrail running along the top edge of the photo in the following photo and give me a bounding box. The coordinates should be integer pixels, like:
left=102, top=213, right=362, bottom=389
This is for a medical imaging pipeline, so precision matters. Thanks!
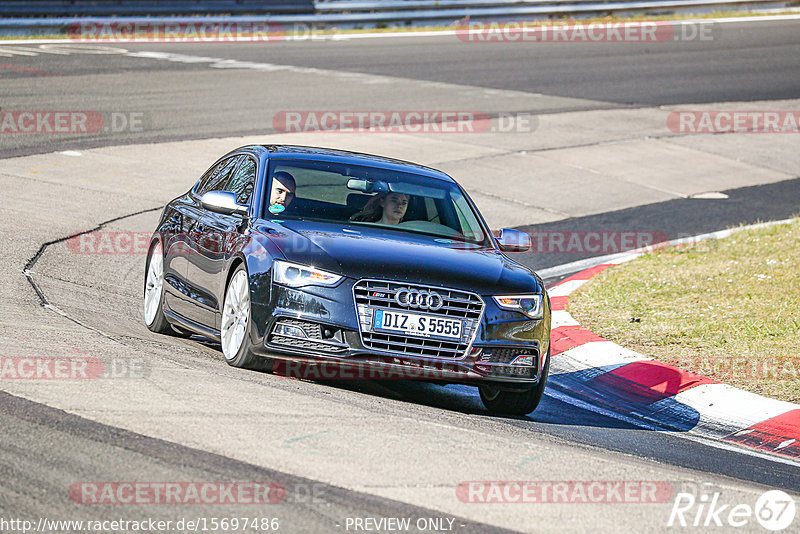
left=0, top=0, right=793, bottom=35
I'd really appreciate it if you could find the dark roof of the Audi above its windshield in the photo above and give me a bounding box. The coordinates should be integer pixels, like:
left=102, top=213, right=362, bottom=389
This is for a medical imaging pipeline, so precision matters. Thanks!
left=243, top=145, right=455, bottom=183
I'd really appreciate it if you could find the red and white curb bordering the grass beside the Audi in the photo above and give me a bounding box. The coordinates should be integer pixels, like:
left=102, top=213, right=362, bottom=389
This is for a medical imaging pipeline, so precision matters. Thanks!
left=540, top=220, right=800, bottom=459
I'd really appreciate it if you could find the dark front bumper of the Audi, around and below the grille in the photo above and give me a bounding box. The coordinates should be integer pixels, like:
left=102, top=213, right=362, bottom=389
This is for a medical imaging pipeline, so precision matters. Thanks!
left=253, top=279, right=550, bottom=388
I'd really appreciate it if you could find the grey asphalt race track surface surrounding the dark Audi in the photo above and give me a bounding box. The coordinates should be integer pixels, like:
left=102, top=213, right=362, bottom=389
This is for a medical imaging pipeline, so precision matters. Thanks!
left=0, top=16, right=800, bottom=533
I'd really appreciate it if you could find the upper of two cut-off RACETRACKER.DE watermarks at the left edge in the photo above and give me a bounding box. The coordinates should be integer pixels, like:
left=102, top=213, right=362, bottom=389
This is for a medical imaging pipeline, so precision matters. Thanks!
left=0, top=109, right=145, bottom=135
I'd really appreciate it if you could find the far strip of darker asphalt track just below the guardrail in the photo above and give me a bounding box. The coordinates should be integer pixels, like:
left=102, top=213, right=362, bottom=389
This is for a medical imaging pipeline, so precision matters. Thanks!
left=0, top=20, right=800, bottom=156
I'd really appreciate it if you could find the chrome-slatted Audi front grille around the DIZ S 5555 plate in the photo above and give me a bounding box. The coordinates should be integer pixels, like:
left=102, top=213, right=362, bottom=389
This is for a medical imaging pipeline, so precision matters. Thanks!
left=353, top=280, right=483, bottom=359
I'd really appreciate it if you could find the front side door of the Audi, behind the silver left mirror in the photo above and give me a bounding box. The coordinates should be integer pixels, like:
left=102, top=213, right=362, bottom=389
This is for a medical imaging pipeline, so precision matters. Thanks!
left=188, top=155, right=256, bottom=330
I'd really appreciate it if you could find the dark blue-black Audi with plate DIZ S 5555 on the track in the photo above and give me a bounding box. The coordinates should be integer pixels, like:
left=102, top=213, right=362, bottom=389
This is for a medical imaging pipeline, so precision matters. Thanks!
left=144, top=145, right=550, bottom=414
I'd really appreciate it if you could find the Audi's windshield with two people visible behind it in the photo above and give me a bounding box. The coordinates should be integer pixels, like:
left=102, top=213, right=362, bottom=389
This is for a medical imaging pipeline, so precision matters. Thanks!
left=265, top=160, right=490, bottom=246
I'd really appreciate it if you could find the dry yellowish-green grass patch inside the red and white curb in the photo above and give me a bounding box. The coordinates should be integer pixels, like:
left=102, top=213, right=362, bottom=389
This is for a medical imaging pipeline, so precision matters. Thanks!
left=568, top=219, right=800, bottom=402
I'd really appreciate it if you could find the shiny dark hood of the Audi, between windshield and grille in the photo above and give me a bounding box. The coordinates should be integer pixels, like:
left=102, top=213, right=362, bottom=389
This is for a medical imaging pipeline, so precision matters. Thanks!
left=257, top=220, right=542, bottom=294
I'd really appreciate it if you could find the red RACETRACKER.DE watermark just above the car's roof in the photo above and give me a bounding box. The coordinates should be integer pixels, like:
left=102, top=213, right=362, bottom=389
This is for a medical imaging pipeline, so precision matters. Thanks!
left=272, top=109, right=538, bottom=134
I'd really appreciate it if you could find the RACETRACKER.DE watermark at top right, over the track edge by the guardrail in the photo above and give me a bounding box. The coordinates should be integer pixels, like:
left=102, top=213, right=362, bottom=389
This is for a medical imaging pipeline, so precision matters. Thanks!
left=456, top=20, right=719, bottom=44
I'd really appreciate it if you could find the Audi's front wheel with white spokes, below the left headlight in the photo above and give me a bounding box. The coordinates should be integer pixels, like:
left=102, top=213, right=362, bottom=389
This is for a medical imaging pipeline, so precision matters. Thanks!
left=220, top=265, right=272, bottom=371
